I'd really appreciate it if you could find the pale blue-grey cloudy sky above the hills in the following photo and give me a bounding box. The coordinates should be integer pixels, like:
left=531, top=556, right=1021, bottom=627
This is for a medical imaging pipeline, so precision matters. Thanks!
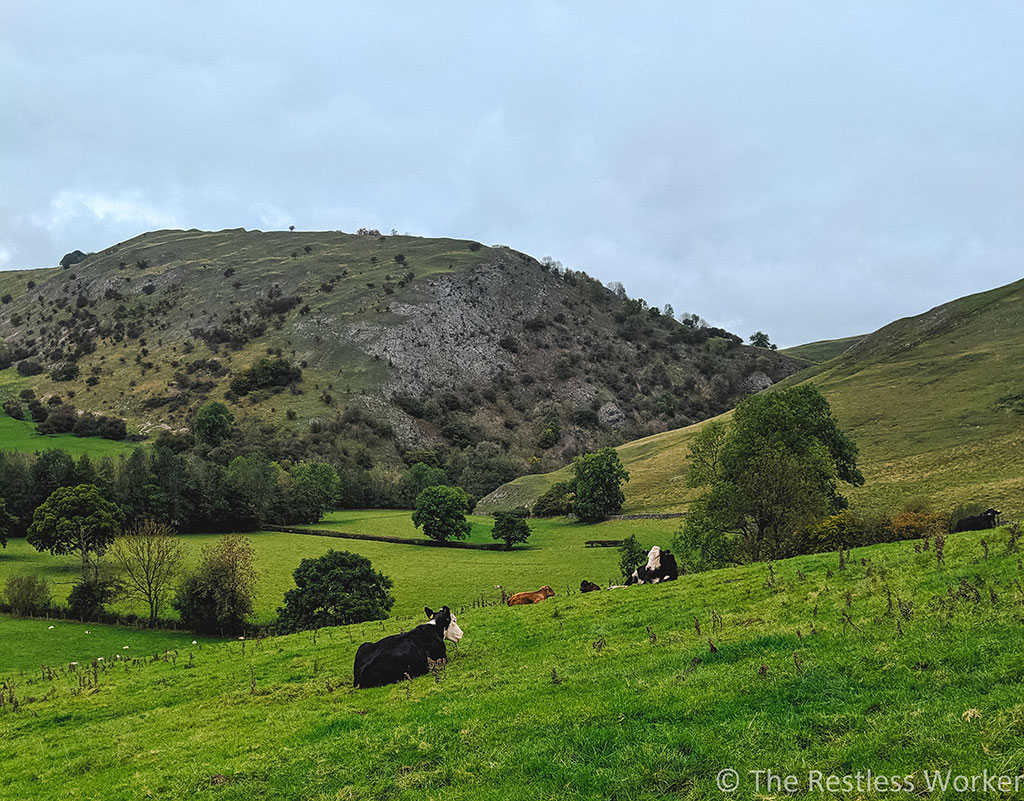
left=0, top=0, right=1024, bottom=346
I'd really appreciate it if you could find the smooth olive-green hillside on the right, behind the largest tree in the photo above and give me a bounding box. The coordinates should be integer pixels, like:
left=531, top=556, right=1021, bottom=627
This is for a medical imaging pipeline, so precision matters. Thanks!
left=478, top=281, right=1024, bottom=515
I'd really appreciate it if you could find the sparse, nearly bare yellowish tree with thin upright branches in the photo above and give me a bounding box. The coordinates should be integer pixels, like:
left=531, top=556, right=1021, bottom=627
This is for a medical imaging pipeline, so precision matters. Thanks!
left=111, top=520, right=185, bottom=624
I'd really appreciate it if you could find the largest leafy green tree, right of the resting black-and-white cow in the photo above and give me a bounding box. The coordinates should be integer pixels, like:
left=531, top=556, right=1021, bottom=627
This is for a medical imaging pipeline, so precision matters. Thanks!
left=677, top=385, right=864, bottom=568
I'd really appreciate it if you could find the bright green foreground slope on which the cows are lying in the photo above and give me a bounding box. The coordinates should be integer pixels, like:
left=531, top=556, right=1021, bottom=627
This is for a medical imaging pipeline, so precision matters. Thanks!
left=0, top=532, right=1024, bottom=801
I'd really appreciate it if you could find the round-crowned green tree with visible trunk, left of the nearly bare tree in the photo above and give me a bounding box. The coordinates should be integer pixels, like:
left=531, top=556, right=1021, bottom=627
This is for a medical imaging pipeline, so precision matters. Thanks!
left=26, top=483, right=125, bottom=576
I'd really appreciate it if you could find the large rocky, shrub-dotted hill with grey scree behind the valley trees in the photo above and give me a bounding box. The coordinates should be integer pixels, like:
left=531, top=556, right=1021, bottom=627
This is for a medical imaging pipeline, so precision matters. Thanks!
left=0, top=230, right=798, bottom=489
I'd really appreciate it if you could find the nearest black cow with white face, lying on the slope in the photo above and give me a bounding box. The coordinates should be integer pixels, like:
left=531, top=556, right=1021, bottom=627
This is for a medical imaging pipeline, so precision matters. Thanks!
left=352, top=606, right=462, bottom=688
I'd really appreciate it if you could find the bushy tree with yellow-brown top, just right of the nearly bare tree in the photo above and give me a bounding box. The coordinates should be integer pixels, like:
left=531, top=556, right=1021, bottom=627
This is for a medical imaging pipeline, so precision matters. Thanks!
left=172, top=535, right=256, bottom=635
